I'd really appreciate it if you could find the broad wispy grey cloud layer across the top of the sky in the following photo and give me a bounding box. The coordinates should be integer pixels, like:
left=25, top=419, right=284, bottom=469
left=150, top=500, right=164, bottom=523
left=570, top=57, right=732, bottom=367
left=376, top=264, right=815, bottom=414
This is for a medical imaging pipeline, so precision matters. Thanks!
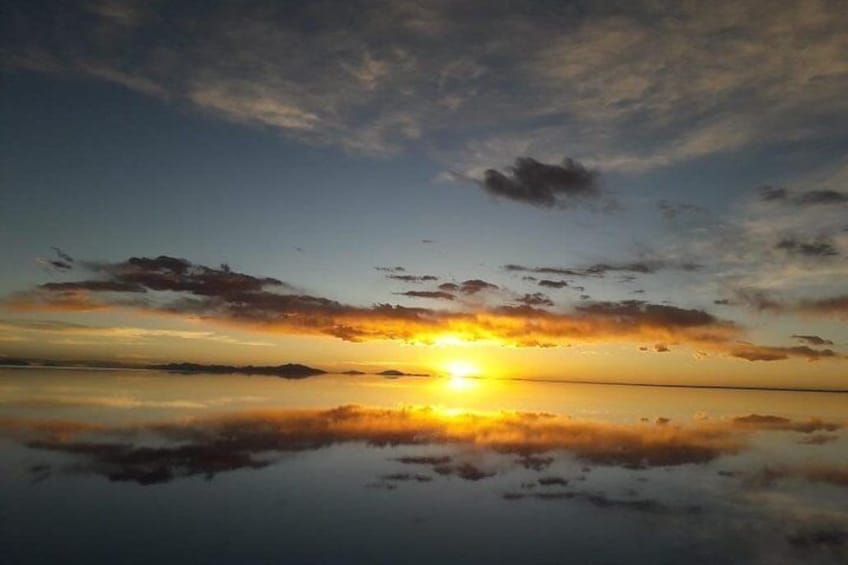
left=6, top=0, right=848, bottom=170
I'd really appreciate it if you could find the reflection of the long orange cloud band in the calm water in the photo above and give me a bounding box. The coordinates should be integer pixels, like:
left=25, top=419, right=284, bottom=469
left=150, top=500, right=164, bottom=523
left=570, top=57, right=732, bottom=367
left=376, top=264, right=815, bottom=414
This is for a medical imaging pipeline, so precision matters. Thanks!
left=0, top=406, right=756, bottom=484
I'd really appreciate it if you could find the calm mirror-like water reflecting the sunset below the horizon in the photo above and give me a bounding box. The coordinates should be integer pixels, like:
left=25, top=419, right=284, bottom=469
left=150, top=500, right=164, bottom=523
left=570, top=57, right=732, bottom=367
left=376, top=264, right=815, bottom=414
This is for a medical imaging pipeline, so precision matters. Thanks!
left=0, top=369, right=848, bottom=564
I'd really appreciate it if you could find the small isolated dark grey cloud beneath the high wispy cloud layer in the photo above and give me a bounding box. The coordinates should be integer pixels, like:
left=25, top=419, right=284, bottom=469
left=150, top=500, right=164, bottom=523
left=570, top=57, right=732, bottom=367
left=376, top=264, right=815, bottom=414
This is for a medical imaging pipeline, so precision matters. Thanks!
left=480, top=157, right=602, bottom=208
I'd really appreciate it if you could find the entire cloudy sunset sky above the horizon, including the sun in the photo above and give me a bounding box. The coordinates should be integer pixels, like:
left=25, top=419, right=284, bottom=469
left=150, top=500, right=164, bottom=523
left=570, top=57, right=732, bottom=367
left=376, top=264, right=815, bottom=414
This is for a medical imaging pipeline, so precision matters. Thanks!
left=0, top=0, right=848, bottom=388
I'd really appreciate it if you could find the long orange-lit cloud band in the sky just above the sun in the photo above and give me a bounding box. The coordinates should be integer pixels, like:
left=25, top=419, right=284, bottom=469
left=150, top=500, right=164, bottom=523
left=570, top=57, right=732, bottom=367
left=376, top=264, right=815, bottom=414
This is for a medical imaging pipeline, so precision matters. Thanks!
left=2, top=252, right=839, bottom=361
